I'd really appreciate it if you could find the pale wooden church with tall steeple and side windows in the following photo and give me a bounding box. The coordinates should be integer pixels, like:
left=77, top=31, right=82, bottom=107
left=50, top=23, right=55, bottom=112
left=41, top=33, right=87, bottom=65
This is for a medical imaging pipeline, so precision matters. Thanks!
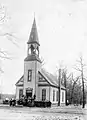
left=15, top=18, right=66, bottom=105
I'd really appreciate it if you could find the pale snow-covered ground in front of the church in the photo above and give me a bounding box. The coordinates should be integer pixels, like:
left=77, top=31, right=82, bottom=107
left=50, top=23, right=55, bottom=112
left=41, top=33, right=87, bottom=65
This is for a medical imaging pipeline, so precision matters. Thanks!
left=0, top=107, right=84, bottom=120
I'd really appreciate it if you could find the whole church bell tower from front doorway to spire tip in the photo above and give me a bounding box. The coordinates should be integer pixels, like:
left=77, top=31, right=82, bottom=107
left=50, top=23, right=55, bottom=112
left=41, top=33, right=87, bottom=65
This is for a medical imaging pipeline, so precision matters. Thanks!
left=23, top=18, right=41, bottom=99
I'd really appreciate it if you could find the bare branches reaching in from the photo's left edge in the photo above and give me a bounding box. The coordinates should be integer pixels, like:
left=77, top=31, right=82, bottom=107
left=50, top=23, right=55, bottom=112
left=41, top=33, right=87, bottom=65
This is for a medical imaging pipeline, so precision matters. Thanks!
left=0, top=4, right=19, bottom=73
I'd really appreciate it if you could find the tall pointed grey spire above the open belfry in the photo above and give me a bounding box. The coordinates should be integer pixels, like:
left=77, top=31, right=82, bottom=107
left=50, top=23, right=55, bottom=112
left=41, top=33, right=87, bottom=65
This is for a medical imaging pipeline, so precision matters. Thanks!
left=27, top=17, right=40, bottom=45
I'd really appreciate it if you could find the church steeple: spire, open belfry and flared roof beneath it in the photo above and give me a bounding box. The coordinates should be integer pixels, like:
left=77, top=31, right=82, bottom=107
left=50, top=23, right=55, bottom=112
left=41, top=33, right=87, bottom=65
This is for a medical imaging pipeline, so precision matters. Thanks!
left=25, top=18, right=41, bottom=62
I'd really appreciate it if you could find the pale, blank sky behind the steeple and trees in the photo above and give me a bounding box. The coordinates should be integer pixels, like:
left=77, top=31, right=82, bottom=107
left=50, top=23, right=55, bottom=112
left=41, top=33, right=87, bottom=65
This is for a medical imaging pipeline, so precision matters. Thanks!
left=0, top=0, right=87, bottom=94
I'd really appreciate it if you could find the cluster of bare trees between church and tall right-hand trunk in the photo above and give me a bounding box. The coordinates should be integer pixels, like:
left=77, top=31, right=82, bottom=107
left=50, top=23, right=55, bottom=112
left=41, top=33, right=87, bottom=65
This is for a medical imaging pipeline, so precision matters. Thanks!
left=66, top=73, right=82, bottom=105
